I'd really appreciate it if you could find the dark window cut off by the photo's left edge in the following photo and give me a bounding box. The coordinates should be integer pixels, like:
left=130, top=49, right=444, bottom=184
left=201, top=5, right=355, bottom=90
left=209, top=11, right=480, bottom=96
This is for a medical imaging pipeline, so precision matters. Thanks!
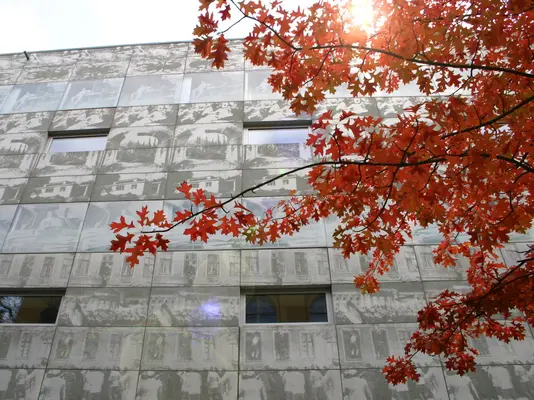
left=0, top=294, right=63, bottom=324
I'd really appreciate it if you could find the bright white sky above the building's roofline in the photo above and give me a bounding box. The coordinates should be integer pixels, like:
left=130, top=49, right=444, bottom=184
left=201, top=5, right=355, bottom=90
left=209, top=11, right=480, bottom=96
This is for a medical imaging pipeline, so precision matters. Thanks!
left=0, top=0, right=311, bottom=53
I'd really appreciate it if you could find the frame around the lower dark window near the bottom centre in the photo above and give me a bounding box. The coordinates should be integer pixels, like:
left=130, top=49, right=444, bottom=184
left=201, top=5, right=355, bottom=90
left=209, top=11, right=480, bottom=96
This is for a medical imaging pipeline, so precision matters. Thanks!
left=239, top=286, right=334, bottom=328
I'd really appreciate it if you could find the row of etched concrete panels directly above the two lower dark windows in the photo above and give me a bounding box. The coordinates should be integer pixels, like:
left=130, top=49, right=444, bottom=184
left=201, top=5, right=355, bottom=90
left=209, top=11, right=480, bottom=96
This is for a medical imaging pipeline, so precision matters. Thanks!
left=0, top=243, right=528, bottom=292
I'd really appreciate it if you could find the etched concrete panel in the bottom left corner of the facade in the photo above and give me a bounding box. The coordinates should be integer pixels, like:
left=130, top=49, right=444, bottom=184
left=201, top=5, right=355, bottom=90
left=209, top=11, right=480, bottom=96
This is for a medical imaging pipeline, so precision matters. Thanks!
left=0, top=369, right=44, bottom=400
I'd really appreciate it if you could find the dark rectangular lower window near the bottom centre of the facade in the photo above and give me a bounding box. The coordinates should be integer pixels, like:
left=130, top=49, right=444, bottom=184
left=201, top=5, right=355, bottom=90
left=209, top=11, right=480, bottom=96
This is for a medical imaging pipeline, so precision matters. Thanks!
left=246, top=293, right=328, bottom=324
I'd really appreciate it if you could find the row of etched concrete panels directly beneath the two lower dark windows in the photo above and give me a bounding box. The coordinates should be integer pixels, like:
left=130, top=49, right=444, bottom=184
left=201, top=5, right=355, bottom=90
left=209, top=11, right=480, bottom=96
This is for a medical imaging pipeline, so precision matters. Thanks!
left=0, top=322, right=534, bottom=371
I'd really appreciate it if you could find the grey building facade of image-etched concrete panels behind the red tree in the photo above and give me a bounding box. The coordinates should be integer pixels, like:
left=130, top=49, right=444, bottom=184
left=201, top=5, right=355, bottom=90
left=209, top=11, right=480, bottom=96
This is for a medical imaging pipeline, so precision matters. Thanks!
left=0, top=42, right=534, bottom=400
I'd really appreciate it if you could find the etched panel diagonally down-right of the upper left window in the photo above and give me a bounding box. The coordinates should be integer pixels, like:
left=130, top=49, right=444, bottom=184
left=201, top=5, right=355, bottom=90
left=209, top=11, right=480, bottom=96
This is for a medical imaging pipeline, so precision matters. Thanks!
left=99, top=147, right=168, bottom=174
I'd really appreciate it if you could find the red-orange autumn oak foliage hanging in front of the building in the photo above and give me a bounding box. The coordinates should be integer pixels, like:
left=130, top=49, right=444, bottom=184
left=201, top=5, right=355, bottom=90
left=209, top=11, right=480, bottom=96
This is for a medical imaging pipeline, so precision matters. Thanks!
left=111, top=0, right=534, bottom=383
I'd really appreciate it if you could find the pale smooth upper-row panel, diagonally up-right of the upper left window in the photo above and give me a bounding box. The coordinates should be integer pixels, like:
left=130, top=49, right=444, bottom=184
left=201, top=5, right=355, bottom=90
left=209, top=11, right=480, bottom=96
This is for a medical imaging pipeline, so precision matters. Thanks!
left=119, top=75, right=183, bottom=107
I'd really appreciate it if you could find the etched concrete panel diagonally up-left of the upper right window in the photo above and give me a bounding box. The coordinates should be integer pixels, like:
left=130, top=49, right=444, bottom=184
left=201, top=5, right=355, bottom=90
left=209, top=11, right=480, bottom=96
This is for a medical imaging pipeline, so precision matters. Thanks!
left=178, top=101, right=243, bottom=124
